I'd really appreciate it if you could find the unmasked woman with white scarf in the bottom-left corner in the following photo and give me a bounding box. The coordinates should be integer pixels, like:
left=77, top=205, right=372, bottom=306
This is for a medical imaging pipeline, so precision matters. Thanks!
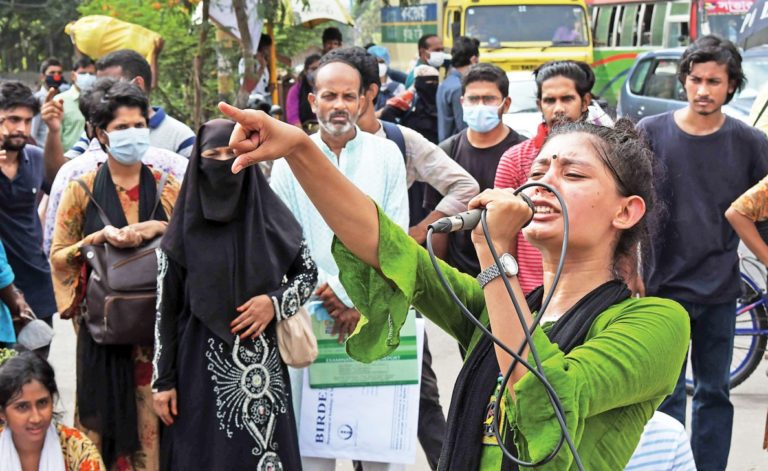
left=0, top=352, right=105, bottom=471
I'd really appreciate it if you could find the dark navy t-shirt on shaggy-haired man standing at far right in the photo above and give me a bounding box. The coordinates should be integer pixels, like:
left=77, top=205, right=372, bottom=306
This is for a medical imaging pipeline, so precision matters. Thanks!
left=638, top=112, right=768, bottom=304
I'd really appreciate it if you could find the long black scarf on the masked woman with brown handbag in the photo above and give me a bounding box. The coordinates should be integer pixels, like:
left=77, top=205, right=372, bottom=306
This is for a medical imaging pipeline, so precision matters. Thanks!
left=77, top=164, right=168, bottom=468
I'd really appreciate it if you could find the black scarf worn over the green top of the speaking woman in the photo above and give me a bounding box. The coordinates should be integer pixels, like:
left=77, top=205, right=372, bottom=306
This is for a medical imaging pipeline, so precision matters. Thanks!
left=438, top=280, right=631, bottom=471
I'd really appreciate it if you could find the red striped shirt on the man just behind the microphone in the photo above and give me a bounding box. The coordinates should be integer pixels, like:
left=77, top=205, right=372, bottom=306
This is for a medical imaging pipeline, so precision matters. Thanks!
left=493, top=132, right=549, bottom=294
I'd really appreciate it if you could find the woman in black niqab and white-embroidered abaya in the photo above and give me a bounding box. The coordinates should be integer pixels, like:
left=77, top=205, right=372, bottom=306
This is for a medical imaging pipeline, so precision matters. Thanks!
left=152, top=119, right=317, bottom=470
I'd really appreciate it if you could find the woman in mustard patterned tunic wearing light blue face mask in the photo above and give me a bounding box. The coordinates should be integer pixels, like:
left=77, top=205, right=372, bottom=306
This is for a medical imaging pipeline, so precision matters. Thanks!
left=51, top=79, right=179, bottom=470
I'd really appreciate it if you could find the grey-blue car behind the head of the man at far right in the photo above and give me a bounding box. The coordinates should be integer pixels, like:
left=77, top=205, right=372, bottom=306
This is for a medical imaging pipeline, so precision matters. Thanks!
left=617, top=46, right=768, bottom=124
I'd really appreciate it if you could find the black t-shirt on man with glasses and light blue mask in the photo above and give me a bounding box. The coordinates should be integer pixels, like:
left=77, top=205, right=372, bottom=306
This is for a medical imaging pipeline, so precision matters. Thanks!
left=424, top=129, right=525, bottom=276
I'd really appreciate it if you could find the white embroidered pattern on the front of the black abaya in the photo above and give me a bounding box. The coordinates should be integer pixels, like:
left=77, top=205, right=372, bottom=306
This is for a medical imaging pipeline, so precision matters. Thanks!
left=205, top=335, right=287, bottom=471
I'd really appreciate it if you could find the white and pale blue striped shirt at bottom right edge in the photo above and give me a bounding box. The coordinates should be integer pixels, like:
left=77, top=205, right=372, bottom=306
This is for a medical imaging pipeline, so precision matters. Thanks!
left=624, top=411, right=696, bottom=471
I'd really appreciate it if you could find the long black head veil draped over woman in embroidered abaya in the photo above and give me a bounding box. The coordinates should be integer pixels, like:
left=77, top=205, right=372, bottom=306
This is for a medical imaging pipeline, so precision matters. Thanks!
left=161, top=119, right=302, bottom=346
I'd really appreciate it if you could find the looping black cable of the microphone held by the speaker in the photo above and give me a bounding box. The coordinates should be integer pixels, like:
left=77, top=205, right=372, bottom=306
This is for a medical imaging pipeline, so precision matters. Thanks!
left=427, top=182, right=584, bottom=471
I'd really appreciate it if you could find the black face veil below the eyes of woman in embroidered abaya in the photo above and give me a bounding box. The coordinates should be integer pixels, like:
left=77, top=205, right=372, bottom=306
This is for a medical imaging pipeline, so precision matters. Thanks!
left=199, top=158, right=245, bottom=222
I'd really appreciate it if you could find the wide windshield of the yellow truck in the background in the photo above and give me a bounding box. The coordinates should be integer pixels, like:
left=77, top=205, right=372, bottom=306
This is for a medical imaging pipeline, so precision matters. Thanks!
left=464, top=5, right=589, bottom=47
